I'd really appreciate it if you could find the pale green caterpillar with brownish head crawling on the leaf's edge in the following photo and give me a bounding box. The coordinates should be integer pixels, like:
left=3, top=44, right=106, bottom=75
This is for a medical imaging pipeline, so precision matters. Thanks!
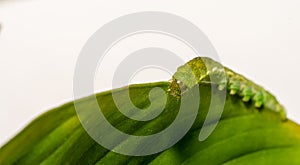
left=168, top=57, right=286, bottom=120
